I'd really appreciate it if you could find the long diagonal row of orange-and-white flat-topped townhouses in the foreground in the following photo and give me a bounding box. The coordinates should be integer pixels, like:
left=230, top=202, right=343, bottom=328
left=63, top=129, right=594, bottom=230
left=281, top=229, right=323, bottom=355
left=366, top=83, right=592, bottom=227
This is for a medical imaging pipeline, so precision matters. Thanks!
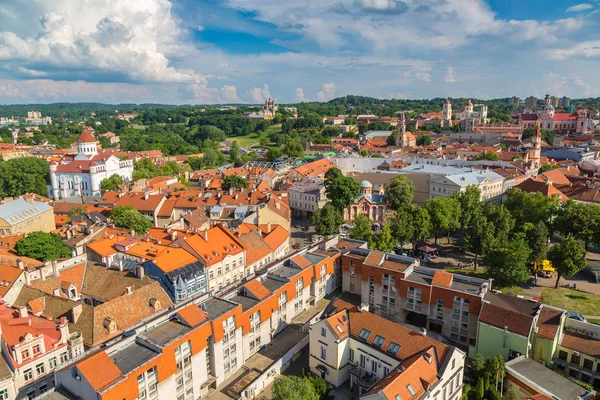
left=49, top=241, right=350, bottom=400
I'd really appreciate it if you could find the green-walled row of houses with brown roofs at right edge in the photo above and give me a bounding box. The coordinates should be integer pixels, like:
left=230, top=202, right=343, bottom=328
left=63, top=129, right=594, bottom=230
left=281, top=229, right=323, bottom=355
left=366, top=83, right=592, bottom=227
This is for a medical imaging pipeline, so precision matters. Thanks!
left=469, top=293, right=600, bottom=390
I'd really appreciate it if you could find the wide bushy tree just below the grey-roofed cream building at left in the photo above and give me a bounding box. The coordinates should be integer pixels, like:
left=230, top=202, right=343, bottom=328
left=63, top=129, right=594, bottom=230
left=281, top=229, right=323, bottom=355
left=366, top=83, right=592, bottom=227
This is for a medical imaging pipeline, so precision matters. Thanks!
left=15, top=232, right=71, bottom=261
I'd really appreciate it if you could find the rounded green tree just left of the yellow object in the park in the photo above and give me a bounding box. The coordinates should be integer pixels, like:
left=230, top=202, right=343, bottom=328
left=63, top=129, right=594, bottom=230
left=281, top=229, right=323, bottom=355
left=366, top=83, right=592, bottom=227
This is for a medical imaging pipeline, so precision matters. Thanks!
left=484, top=233, right=531, bottom=286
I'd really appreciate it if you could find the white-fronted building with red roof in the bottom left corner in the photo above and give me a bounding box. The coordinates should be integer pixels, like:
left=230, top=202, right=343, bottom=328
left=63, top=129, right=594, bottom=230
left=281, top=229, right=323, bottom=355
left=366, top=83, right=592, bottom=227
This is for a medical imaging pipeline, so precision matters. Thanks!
left=0, top=299, right=84, bottom=399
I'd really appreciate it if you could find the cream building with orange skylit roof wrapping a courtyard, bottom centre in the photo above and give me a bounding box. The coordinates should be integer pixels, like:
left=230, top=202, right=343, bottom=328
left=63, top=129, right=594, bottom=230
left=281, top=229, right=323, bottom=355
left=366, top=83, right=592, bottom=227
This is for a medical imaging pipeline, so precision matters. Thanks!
left=309, top=299, right=466, bottom=400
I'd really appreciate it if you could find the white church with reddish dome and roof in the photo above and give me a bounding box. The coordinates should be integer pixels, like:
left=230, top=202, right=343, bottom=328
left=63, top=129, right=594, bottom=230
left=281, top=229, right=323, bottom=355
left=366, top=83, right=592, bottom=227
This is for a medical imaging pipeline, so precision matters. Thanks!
left=50, top=130, right=133, bottom=200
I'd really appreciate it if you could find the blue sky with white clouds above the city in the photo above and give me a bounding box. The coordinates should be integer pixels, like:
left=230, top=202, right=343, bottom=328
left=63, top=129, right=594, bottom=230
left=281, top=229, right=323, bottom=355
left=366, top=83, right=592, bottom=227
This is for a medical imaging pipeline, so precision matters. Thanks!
left=0, top=0, right=600, bottom=104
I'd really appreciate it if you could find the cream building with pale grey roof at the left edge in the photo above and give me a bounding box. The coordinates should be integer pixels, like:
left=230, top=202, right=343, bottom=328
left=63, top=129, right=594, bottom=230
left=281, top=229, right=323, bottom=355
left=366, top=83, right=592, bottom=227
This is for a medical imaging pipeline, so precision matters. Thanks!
left=0, top=195, right=56, bottom=237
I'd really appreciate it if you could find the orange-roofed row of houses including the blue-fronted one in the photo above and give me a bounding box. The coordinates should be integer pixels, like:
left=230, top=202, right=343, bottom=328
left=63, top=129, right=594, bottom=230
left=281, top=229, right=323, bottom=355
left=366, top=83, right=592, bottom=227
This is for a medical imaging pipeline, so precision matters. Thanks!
left=87, top=224, right=290, bottom=302
